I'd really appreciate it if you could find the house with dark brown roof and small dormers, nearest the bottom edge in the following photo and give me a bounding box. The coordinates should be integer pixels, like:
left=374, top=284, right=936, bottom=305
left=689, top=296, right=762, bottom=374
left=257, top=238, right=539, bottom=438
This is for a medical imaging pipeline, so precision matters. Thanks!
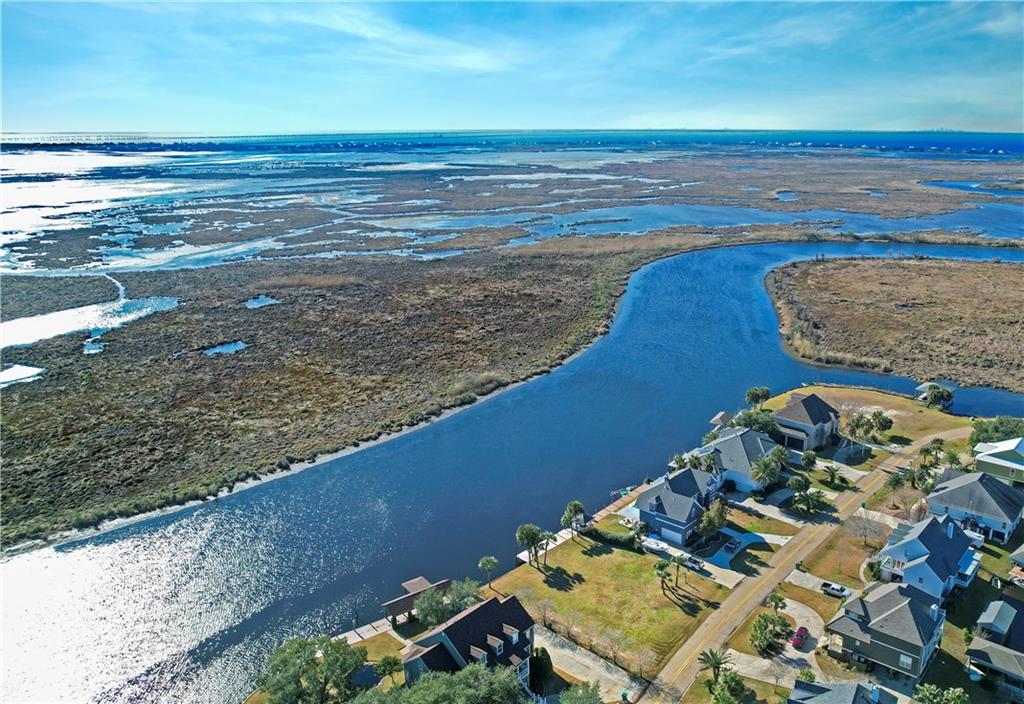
left=401, top=597, right=534, bottom=691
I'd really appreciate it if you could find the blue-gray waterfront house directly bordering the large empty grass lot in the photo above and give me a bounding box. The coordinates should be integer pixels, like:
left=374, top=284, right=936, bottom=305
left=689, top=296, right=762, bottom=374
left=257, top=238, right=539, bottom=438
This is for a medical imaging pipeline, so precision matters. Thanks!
left=635, top=468, right=722, bottom=545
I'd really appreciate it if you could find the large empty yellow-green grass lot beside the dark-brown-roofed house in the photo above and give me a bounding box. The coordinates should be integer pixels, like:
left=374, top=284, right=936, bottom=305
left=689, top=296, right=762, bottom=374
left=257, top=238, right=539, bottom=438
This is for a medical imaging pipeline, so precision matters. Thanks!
left=494, top=537, right=729, bottom=673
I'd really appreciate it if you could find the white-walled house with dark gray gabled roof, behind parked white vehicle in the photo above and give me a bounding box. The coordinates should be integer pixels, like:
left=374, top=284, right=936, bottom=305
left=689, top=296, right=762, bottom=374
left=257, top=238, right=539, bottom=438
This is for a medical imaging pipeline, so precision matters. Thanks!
left=879, top=516, right=981, bottom=601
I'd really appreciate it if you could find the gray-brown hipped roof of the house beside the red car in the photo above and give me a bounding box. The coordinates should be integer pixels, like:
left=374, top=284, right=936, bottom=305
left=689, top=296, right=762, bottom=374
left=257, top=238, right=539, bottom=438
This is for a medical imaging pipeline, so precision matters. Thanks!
left=827, top=582, right=941, bottom=648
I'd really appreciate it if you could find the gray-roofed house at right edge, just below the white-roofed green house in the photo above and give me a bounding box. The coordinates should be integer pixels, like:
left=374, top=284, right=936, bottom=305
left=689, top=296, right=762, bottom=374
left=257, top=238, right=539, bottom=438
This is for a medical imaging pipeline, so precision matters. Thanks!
left=927, top=472, right=1024, bottom=544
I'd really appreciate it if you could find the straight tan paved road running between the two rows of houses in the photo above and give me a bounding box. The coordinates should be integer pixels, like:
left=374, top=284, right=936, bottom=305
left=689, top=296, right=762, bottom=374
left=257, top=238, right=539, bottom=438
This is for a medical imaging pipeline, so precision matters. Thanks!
left=639, top=428, right=971, bottom=704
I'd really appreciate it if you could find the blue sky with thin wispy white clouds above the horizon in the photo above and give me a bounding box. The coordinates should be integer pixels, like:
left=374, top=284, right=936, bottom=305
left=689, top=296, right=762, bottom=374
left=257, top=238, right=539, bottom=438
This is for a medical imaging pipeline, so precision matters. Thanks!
left=2, top=1, right=1024, bottom=134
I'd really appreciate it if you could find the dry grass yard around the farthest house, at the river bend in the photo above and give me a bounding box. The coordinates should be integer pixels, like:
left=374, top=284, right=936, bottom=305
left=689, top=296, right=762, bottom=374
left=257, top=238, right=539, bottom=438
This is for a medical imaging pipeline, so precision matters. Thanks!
left=765, top=386, right=971, bottom=446
